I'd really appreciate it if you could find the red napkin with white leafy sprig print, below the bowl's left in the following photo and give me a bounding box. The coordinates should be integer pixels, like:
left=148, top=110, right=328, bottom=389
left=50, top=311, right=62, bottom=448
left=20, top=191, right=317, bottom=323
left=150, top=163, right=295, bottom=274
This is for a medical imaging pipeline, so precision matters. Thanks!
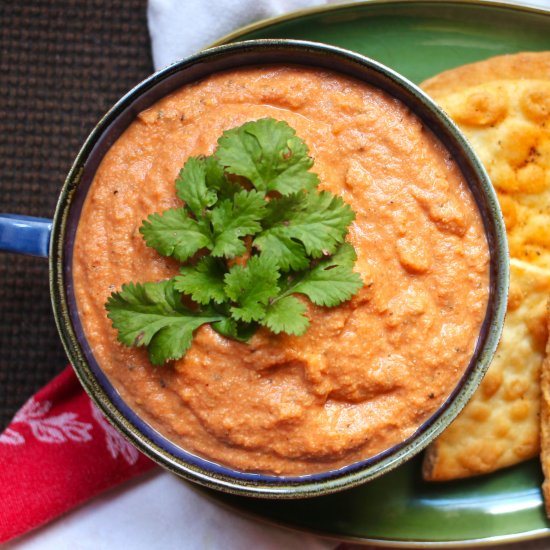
left=0, top=367, right=154, bottom=543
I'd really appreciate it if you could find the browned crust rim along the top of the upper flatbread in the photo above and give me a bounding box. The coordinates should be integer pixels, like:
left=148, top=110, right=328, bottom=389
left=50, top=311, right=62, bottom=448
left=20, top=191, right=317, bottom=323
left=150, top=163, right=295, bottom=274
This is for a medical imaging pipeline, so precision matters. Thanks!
left=420, top=51, right=550, bottom=95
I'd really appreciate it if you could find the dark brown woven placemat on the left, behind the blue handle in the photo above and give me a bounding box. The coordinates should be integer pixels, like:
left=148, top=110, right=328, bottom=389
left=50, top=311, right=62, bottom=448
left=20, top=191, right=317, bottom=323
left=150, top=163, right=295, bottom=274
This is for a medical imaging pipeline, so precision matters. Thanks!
left=0, top=0, right=152, bottom=430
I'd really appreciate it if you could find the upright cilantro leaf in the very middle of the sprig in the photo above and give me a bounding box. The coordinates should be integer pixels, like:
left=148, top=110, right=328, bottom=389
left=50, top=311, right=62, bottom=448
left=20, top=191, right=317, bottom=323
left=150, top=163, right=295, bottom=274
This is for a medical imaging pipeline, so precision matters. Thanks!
left=211, top=189, right=266, bottom=258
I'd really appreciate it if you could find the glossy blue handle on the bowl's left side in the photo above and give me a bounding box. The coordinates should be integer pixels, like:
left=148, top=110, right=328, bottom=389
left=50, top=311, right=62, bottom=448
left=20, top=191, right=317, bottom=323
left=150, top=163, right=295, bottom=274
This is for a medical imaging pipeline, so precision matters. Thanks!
left=0, top=214, right=52, bottom=258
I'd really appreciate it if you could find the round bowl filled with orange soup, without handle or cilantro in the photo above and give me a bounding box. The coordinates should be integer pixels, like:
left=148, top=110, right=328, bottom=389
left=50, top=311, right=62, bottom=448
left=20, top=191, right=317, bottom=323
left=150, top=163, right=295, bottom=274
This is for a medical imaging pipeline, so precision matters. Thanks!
left=15, top=40, right=508, bottom=498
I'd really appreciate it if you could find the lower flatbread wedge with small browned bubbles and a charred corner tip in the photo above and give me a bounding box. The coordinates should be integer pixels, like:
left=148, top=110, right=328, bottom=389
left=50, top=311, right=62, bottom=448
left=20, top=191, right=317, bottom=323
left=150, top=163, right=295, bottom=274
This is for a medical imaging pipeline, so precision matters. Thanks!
left=423, top=259, right=550, bottom=481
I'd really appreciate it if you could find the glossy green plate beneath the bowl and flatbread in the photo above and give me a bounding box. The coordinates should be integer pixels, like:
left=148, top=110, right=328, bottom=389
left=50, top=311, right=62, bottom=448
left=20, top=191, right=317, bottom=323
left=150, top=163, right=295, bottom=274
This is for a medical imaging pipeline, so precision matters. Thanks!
left=211, top=1, right=550, bottom=547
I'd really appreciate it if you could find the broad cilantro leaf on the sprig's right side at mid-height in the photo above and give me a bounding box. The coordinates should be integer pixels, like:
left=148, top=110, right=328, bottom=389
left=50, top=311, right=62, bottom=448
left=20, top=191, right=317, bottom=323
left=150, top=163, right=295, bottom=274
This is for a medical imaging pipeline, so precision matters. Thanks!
left=253, top=191, right=355, bottom=270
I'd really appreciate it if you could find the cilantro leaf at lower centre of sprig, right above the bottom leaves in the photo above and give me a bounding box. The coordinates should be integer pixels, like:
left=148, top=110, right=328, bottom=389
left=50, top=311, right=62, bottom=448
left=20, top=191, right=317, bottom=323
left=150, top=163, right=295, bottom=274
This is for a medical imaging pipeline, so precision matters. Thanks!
left=225, top=256, right=280, bottom=323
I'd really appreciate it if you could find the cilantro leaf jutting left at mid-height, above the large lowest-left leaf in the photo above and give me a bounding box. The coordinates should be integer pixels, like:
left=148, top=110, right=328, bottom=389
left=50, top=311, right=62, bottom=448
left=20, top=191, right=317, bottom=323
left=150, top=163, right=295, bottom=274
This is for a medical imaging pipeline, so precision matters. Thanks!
left=139, top=208, right=213, bottom=262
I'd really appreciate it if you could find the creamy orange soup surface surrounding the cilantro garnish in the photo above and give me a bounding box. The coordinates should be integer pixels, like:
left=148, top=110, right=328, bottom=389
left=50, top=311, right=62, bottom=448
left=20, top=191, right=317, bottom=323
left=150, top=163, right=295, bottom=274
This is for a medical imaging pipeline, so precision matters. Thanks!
left=73, top=67, right=489, bottom=474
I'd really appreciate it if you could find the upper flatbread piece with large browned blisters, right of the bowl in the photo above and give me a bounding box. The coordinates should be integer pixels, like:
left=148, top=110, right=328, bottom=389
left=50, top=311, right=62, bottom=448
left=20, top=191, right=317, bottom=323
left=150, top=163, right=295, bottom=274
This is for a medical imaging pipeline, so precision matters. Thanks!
left=421, top=52, right=550, bottom=269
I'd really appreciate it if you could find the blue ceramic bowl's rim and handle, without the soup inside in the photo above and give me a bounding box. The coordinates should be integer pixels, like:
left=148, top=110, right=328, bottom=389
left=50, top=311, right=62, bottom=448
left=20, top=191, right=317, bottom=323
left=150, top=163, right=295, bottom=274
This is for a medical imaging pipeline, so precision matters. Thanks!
left=0, top=40, right=508, bottom=498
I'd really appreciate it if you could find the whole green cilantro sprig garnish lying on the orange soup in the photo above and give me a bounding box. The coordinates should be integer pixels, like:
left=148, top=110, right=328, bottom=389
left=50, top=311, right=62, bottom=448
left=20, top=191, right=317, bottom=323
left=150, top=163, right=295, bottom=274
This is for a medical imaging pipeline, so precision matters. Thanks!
left=106, top=118, right=362, bottom=365
